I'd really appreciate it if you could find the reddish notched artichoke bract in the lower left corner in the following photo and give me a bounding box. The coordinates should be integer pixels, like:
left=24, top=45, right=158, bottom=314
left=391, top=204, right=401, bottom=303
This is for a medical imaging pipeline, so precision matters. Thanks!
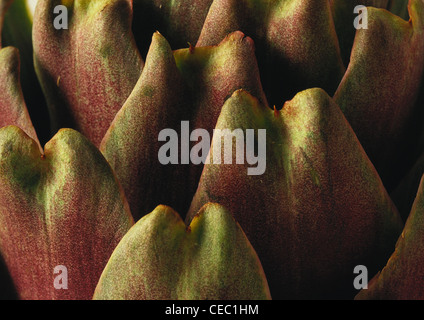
left=0, top=126, right=134, bottom=299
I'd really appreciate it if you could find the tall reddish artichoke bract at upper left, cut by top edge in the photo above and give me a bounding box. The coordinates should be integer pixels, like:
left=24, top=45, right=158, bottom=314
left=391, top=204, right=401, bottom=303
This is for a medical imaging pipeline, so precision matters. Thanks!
left=33, top=0, right=143, bottom=145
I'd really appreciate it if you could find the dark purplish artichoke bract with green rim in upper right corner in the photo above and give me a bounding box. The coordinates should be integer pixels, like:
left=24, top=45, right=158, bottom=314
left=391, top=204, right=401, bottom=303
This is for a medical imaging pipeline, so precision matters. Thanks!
left=334, top=0, right=424, bottom=189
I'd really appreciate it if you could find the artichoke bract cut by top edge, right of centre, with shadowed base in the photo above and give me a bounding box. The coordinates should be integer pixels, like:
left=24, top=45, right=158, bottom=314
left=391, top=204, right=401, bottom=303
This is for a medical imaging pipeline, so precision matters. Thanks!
left=197, top=0, right=345, bottom=106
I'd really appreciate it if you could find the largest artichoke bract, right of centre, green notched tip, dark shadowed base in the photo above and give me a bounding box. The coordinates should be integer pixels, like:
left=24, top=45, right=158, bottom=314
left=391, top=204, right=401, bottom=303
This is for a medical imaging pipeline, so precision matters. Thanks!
left=187, top=89, right=403, bottom=299
